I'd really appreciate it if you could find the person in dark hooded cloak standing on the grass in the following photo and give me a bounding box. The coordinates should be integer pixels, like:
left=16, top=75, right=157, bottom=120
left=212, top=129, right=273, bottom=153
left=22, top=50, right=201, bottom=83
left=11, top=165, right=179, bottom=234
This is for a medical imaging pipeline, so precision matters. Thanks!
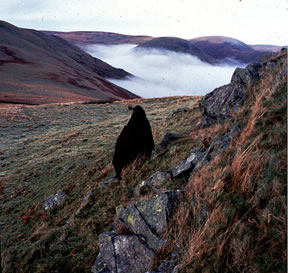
left=112, top=105, right=154, bottom=180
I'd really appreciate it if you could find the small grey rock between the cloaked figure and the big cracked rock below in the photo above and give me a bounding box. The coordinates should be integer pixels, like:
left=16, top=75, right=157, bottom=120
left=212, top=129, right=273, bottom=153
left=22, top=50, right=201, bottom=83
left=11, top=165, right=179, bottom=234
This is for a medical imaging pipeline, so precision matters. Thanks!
left=134, top=171, right=171, bottom=196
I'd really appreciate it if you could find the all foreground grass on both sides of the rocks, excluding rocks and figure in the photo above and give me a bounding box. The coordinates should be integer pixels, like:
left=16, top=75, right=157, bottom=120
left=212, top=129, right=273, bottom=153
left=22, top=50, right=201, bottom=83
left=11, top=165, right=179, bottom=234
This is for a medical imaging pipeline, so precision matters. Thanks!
left=0, top=51, right=287, bottom=272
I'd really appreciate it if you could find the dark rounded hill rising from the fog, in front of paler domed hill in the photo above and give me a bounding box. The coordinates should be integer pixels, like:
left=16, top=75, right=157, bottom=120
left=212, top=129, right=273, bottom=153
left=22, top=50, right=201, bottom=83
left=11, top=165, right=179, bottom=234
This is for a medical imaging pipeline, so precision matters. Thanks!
left=136, top=37, right=217, bottom=64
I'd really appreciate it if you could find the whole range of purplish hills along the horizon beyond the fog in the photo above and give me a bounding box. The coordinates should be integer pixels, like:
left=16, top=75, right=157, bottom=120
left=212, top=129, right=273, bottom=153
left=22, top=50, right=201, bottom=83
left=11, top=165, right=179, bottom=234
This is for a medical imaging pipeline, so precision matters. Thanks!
left=43, top=31, right=282, bottom=64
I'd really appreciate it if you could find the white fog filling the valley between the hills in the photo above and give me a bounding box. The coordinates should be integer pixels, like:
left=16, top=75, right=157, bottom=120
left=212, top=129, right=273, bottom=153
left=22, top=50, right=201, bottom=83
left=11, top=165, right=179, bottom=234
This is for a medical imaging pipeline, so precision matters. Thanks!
left=85, top=44, right=242, bottom=98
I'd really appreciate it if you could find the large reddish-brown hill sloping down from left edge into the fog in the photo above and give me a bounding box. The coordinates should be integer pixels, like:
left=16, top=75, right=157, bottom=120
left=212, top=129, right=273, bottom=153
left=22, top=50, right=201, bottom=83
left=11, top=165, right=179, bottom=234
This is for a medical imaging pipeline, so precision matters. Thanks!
left=0, top=21, right=137, bottom=104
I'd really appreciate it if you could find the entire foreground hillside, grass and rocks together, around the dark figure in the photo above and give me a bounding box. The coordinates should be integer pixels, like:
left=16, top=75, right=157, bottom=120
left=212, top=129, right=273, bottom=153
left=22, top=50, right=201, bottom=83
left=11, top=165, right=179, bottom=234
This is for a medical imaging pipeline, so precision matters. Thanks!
left=0, top=50, right=287, bottom=273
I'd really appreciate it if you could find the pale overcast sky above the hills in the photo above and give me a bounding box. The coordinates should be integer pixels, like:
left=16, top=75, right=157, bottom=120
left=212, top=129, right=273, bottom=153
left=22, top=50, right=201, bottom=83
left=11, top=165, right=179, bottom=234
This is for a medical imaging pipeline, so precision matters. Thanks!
left=0, top=0, right=288, bottom=45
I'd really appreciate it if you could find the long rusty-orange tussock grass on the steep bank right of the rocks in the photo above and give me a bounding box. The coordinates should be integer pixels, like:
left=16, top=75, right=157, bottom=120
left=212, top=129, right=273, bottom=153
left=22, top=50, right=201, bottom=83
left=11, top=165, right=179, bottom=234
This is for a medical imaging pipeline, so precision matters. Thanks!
left=154, top=52, right=287, bottom=272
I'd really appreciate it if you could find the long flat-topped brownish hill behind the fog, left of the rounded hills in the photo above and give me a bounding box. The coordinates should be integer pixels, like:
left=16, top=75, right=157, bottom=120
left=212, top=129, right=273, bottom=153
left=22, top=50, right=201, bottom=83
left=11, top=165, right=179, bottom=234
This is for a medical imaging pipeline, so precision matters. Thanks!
left=42, top=31, right=153, bottom=45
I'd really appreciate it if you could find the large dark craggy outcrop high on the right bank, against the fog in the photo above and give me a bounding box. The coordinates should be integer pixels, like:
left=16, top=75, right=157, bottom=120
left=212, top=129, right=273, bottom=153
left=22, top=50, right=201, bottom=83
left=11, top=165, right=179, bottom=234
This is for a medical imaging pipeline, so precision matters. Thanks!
left=199, top=63, right=262, bottom=128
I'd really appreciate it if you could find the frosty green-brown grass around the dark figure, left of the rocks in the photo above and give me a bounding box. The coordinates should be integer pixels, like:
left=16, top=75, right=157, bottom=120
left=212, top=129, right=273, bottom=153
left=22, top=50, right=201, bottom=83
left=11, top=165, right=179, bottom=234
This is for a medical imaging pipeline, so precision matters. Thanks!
left=0, top=97, right=199, bottom=272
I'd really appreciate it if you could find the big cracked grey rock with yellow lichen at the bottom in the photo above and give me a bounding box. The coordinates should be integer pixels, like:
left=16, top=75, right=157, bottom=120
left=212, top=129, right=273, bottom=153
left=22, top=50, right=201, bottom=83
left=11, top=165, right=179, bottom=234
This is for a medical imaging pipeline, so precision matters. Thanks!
left=92, top=191, right=179, bottom=273
